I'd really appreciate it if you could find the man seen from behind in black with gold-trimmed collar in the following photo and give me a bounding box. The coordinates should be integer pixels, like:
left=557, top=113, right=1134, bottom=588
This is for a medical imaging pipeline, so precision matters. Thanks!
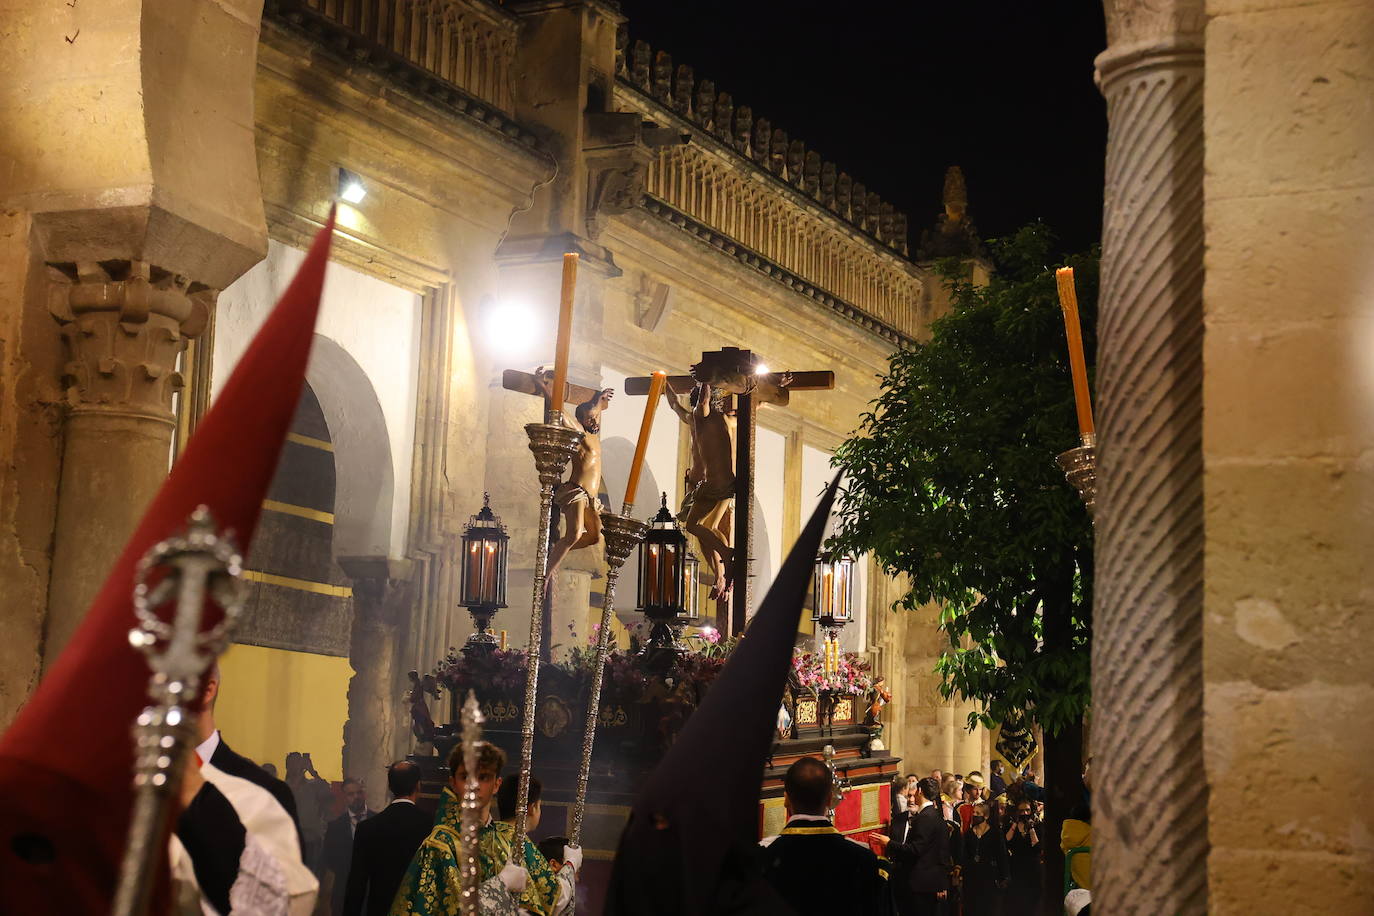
left=760, top=757, right=886, bottom=916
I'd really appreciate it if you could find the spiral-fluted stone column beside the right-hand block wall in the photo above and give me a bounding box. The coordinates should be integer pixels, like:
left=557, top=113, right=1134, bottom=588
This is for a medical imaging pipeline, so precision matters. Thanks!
left=1092, top=0, right=1208, bottom=913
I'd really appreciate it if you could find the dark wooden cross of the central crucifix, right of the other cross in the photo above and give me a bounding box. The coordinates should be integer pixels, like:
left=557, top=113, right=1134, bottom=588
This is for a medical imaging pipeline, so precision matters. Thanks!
left=625, top=346, right=835, bottom=636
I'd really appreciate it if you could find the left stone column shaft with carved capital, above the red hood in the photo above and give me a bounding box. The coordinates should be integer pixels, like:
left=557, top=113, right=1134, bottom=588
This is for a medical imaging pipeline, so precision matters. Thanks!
left=43, top=261, right=209, bottom=669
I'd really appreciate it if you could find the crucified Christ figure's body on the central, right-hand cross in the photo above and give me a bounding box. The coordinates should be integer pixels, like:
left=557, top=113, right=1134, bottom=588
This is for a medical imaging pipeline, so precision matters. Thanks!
left=683, top=382, right=735, bottom=600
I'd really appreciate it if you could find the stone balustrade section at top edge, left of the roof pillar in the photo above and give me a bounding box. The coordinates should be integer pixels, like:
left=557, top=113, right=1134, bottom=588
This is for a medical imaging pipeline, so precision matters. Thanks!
left=298, top=0, right=519, bottom=115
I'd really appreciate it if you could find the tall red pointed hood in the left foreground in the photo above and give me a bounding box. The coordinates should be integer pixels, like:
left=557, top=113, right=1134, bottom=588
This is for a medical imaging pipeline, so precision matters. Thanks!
left=0, top=213, right=334, bottom=915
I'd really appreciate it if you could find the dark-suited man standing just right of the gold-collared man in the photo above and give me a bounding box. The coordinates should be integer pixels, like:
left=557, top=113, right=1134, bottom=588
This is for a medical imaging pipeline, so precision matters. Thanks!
left=878, top=776, right=951, bottom=916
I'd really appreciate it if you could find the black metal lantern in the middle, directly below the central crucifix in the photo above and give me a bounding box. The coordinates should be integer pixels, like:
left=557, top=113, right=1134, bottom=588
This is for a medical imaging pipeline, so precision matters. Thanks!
left=639, top=493, right=701, bottom=652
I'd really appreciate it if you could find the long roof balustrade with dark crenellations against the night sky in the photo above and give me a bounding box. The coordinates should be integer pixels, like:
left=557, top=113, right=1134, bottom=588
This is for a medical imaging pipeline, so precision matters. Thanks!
left=616, top=33, right=925, bottom=342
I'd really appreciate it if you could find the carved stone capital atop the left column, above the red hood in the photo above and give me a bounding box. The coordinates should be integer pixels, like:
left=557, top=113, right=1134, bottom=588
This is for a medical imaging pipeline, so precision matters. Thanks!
left=49, top=261, right=214, bottom=424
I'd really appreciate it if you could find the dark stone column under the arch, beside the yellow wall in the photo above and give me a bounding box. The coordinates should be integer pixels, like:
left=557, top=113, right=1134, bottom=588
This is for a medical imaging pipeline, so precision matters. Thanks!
left=338, top=556, right=412, bottom=810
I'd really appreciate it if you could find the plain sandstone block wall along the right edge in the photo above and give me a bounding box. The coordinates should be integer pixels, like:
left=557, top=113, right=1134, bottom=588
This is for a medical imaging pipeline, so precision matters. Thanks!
left=1204, top=0, right=1374, bottom=915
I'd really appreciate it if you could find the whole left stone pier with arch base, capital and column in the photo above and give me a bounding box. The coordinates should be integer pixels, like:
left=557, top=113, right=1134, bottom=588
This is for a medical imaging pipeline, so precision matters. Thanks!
left=0, top=0, right=267, bottom=694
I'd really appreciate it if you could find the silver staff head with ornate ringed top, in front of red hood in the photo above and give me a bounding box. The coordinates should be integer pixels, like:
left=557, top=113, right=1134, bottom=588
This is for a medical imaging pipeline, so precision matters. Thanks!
left=113, top=505, right=245, bottom=916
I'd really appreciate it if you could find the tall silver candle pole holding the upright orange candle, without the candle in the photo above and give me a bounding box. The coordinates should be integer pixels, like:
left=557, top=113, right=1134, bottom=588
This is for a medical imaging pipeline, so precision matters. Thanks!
left=511, top=423, right=583, bottom=864
